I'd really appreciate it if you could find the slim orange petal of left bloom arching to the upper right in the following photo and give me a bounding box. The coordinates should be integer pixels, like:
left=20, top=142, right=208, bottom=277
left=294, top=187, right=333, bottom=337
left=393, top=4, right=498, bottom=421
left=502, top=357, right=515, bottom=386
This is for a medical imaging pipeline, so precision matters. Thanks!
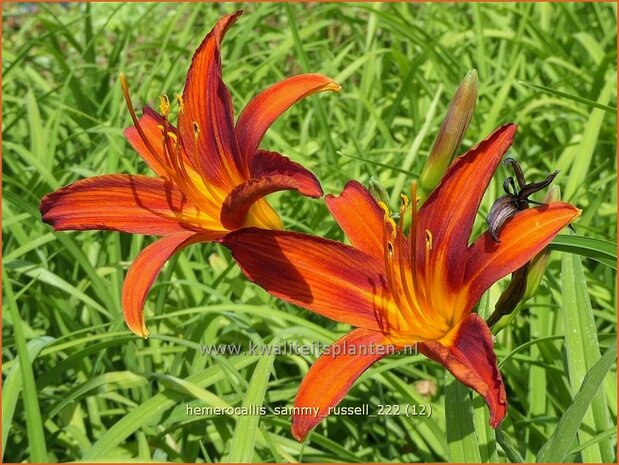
left=236, top=74, right=341, bottom=161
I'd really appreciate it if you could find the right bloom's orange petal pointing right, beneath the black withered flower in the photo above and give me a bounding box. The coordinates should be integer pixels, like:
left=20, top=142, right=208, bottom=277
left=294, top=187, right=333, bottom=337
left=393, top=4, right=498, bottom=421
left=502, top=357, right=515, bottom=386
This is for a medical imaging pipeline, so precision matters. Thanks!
left=465, top=202, right=580, bottom=314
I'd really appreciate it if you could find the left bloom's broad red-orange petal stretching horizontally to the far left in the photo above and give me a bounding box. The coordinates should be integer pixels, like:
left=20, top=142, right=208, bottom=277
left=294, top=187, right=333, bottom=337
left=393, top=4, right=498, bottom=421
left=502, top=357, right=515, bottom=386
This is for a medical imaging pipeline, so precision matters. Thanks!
left=39, top=174, right=221, bottom=235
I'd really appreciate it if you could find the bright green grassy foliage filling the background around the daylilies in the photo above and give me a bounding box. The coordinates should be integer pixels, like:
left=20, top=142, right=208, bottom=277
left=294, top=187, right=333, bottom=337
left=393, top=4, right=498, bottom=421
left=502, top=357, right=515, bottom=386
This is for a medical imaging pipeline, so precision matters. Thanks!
left=2, top=3, right=617, bottom=462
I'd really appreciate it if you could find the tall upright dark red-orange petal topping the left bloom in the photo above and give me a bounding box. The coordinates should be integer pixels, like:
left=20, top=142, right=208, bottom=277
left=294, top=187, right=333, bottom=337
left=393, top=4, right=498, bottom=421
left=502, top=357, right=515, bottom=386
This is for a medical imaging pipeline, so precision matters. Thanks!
left=179, top=11, right=242, bottom=189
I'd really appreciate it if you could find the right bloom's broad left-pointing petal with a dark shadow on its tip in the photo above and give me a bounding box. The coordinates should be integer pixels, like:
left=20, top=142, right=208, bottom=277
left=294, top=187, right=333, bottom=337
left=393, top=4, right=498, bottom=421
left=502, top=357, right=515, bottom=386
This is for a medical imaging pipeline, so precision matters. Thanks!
left=222, top=228, right=396, bottom=331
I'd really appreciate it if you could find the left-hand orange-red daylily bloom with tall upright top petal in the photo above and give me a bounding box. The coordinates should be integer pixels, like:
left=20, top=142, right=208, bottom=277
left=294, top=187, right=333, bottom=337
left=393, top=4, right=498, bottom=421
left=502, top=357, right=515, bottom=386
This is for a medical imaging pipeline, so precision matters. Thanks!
left=40, top=11, right=340, bottom=337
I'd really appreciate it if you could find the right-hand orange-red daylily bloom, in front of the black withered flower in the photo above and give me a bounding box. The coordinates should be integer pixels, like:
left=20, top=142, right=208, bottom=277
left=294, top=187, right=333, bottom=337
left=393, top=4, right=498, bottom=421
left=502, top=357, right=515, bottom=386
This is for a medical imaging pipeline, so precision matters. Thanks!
left=223, top=124, right=580, bottom=440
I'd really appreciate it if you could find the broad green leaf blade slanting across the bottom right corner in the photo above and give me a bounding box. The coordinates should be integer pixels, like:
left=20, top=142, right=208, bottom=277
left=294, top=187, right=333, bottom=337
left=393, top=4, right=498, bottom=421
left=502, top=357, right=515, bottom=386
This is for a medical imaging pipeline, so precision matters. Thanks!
left=536, top=340, right=617, bottom=463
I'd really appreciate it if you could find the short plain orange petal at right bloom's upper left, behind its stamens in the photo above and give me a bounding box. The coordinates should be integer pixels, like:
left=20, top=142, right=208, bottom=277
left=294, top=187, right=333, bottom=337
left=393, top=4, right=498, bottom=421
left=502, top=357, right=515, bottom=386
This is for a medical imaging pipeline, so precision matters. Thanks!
left=325, top=181, right=385, bottom=260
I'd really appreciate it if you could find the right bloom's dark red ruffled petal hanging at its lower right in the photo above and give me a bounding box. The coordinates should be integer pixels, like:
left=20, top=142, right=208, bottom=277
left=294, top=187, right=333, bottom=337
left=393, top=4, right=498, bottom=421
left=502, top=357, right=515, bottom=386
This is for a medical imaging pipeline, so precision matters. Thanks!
left=417, top=314, right=507, bottom=428
